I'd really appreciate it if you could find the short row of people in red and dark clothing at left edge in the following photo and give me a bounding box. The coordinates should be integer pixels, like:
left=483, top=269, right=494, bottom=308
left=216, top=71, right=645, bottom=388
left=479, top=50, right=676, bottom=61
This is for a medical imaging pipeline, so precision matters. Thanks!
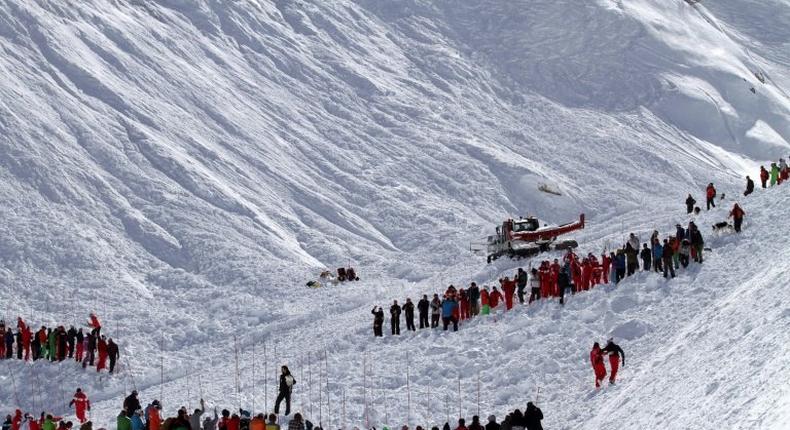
left=0, top=313, right=120, bottom=373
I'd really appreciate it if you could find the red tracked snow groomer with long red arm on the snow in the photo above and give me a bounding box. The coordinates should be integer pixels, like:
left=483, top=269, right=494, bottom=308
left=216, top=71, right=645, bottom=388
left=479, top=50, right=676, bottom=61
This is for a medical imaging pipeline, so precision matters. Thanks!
left=486, top=214, right=584, bottom=263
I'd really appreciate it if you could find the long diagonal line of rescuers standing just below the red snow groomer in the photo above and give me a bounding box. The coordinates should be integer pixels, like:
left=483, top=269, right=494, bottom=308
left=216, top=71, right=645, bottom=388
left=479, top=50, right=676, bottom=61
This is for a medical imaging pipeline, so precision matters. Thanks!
left=371, top=218, right=712, bottom=337
